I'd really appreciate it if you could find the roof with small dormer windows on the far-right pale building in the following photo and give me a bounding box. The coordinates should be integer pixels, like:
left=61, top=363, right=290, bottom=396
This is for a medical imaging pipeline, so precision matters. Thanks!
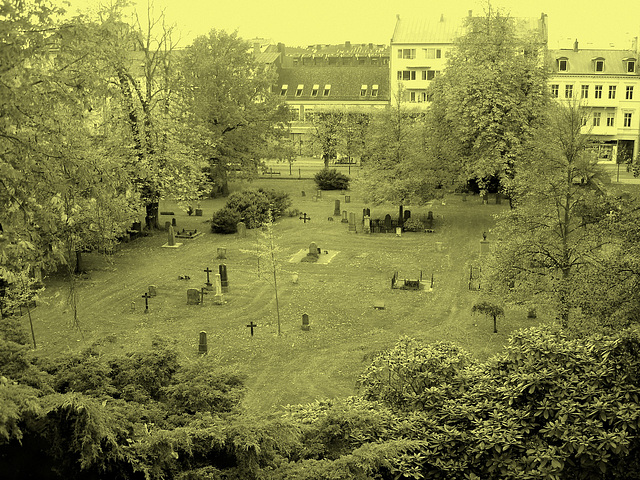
left=548, top=49, right=638, bottom=75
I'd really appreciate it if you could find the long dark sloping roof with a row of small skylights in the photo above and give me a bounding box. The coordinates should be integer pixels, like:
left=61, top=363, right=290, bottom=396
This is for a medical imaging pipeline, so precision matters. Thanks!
left=276, top=66, right=390, bottom=101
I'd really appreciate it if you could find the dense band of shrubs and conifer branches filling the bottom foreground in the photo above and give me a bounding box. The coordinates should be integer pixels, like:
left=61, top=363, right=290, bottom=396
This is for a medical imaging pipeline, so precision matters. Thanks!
left=0, top=320, right=640, bottom=480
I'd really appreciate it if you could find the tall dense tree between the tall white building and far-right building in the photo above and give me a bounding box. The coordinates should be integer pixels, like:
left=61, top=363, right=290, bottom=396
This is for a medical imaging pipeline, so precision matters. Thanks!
left=430, top=4, right=548, bottom=199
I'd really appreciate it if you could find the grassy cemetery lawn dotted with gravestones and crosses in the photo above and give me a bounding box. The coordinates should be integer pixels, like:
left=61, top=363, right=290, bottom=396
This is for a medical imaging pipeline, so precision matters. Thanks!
left=22, top=179, right=544, bottom=413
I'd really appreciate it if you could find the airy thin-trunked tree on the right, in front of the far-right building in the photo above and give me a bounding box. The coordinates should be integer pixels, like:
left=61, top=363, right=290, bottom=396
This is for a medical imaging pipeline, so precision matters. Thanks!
left=489, top=103, right=610, bottom=326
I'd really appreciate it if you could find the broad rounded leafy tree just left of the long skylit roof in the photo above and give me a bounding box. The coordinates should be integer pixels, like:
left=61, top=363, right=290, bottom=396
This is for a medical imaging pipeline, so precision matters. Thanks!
left=174, top=30, right=289, bottom=190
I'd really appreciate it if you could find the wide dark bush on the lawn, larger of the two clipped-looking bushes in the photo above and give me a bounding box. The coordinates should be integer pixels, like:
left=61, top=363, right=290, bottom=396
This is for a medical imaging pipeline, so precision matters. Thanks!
left=211, top=188, right=291, bottom=233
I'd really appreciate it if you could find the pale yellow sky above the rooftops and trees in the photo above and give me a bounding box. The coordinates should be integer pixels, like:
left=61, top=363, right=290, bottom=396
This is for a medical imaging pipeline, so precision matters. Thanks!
left=60, top=0, right=640, bottom=48
